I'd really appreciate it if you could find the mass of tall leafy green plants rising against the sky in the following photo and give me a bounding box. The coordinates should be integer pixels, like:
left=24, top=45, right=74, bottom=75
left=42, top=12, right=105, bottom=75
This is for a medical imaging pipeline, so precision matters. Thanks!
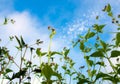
left=0, top=4, right=120, bottom=84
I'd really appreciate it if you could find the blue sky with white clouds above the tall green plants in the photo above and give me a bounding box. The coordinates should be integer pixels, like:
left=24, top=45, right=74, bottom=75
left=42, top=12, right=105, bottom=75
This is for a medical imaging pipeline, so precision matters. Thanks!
left=0, top=0, right=120, bottom=83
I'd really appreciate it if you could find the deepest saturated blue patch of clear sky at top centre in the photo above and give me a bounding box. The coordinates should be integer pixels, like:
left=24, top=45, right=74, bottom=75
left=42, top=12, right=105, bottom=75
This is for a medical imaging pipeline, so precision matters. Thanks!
left=14, top=0, right=76, bottom=25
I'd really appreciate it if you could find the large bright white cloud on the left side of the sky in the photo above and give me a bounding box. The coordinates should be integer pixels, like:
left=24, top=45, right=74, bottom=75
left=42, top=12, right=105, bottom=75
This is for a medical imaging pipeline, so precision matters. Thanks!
left=0, top=11, right=63, bottom=50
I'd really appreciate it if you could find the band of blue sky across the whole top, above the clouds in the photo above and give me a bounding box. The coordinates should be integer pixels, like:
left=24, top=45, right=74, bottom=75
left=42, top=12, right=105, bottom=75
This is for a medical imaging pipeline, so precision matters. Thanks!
left=0, top=0, right=120, bottom=29
